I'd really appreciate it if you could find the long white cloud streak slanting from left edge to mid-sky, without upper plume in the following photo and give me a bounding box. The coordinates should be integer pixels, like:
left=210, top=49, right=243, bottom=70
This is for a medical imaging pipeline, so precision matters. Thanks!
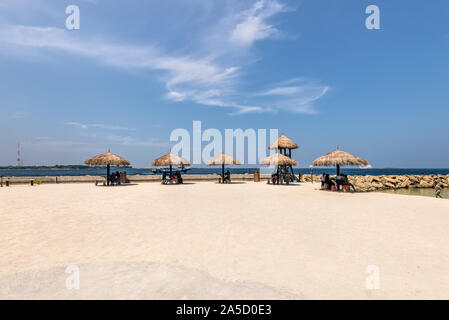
left=0, top=25, right=252, bottom=111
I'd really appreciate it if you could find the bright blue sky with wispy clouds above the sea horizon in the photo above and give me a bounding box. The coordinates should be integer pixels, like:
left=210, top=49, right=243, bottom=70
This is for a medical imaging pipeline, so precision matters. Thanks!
left=0, top=0, right=449, bottom=167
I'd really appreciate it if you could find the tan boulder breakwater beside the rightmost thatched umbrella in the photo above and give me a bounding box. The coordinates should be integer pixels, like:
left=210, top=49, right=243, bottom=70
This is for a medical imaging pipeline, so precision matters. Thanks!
left=301, top=174, right=449, bottom=192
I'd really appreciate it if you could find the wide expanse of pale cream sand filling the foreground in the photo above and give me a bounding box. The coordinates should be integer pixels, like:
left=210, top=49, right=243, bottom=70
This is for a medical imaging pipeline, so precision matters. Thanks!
left=0, top=182, right=449, bottom=299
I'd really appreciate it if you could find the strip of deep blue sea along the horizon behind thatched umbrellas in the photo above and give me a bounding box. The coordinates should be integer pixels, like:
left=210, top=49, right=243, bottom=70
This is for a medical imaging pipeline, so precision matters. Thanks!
left=0, top=166, right=449, bottom=177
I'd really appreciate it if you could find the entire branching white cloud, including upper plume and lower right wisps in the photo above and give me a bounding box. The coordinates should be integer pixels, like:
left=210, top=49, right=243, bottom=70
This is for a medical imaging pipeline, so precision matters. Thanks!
left=0, top=0, right=327, bottom=115
